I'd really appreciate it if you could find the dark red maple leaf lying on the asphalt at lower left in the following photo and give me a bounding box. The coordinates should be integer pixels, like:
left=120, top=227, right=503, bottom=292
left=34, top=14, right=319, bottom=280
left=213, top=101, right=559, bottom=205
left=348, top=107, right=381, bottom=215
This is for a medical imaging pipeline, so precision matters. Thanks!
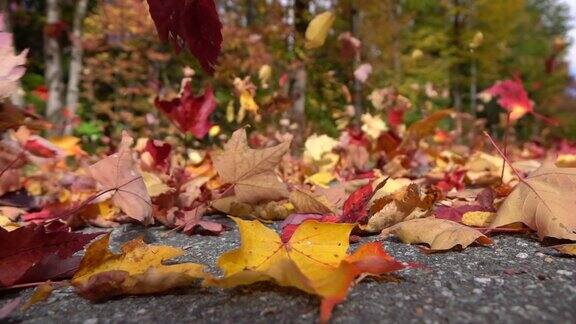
left=0, top=225, right=102, bottom=287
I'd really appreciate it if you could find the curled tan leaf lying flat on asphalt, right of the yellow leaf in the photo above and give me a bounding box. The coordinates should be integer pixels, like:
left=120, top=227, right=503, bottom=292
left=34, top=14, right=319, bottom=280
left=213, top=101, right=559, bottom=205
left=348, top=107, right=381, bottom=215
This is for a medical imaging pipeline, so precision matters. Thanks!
left=382, top=217, right=492, bottom=252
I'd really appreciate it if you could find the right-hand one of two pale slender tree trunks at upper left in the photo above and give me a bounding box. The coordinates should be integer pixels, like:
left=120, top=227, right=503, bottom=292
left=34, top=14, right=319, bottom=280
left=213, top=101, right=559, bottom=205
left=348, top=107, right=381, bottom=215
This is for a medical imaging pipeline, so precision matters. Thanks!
left=65, top=0, right=88, bottom=134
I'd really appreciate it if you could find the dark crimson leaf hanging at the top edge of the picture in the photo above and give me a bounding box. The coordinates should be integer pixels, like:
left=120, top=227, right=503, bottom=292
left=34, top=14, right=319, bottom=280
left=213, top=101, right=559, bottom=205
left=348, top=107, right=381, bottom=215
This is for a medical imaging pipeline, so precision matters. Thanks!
left=147, top=0, right=222, bottom=74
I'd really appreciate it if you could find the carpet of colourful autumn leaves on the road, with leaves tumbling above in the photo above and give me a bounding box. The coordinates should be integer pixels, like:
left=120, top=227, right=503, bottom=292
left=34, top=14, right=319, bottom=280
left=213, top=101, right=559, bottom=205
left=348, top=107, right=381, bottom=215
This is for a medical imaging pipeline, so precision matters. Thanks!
left=0, top=0, right=576, bottom=322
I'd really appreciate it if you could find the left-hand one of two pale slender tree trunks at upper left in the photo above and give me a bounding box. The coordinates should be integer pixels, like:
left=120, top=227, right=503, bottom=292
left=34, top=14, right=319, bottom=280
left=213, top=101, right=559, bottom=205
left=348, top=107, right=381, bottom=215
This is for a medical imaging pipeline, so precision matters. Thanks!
left=44, top=0, right=64, bottom=133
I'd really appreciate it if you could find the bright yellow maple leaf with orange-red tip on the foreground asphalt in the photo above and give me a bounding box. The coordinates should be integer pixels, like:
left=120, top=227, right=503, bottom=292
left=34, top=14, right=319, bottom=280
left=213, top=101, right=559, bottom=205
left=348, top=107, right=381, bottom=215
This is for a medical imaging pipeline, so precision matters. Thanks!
left=207, top=219, right=404, bottom=322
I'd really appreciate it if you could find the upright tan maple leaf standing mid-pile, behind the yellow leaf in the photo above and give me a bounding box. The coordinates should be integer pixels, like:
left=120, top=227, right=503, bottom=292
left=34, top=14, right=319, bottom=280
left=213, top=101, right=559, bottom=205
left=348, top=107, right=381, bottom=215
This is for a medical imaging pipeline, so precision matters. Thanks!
left=214, top=128, right=290, bottom=203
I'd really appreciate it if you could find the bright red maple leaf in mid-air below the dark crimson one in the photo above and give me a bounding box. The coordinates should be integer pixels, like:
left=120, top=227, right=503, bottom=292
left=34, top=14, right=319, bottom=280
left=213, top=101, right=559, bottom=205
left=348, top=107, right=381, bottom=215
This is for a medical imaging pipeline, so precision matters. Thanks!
left=154, top=83, right=216, bottom=139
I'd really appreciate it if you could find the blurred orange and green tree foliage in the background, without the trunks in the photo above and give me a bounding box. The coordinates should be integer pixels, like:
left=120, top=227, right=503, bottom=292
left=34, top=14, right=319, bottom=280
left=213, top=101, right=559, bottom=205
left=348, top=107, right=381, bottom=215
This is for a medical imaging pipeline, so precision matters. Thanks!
left=4, top=0, right=576, bottom=141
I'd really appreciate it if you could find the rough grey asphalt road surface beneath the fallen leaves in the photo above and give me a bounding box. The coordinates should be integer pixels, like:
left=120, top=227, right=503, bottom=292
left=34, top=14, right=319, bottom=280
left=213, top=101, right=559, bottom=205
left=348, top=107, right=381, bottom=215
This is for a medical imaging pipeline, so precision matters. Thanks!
left=0, top=218, right=576, bottom=324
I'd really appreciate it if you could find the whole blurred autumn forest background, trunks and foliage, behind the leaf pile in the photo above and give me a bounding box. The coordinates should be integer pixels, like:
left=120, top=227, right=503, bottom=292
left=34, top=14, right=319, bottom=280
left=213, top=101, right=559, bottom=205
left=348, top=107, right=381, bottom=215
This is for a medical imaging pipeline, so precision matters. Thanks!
left=1, top=0, right=576, bottom=151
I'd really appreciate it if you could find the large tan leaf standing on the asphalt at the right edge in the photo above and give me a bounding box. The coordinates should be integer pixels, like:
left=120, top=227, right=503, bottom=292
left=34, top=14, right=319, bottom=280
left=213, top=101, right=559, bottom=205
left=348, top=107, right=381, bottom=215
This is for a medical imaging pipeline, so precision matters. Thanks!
left=490, top=164, right=576, bottom=240
